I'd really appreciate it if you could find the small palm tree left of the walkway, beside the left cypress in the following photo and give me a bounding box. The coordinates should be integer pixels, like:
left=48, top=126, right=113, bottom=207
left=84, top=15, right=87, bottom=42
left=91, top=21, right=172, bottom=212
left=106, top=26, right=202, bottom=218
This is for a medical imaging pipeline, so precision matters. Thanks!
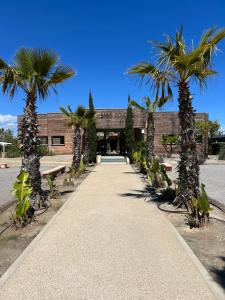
left=60, top=105, right=88, bottom=171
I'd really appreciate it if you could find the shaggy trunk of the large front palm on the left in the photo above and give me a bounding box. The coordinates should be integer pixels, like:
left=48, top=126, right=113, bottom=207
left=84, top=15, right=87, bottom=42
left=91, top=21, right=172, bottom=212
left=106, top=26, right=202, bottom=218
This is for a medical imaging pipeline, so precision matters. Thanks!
left=18, top=93, right=43, bottom=205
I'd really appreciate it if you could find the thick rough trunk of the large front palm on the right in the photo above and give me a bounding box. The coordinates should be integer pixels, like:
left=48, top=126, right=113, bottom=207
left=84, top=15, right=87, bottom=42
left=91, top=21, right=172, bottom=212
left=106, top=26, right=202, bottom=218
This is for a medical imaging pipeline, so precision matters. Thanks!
left=178, top=82, right=199, bottom=206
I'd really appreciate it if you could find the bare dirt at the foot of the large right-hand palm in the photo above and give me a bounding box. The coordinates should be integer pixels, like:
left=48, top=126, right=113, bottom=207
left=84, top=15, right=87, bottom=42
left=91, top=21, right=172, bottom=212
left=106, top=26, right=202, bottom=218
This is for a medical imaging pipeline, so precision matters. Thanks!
left=161, top=204, right=225, bottom=290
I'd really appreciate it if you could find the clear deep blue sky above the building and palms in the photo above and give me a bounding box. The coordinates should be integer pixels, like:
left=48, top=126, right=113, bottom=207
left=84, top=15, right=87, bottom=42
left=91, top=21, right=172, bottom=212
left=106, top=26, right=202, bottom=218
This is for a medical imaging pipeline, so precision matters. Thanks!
left=0, top=0, right=225, bottom=130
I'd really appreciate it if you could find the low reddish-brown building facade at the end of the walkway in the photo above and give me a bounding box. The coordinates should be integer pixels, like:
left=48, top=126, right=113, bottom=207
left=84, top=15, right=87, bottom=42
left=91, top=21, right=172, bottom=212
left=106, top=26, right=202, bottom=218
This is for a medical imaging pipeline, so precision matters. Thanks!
left=32, top=109, right=208, bottom=155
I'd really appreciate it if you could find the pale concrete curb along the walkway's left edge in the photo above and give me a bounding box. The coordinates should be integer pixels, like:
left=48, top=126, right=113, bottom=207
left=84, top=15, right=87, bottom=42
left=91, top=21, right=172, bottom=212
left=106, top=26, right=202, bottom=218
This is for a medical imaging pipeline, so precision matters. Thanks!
left=0, top=168, right=90, bottom=289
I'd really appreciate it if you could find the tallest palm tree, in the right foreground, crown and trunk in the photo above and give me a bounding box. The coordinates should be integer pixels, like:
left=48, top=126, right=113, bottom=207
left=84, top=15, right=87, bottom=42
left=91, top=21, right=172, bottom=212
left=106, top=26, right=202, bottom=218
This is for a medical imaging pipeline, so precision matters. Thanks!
left=154, top=28, right=225, bottom=212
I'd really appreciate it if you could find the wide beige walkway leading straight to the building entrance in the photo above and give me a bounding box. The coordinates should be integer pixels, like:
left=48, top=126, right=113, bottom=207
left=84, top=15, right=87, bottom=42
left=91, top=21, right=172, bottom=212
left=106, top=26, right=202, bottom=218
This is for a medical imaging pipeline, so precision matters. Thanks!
left=0, top=165, right=218, bottom=300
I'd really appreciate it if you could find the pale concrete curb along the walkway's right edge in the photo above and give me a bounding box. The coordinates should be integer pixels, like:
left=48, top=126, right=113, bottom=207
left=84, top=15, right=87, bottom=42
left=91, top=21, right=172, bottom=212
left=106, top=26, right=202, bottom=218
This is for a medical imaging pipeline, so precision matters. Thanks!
left=168, top=216, right=225, bottom=300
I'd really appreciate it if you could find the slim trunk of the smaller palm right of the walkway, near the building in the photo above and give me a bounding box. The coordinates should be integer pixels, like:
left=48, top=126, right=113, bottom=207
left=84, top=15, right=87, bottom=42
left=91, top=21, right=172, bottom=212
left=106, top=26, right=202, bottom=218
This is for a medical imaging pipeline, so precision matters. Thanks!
left=147, top=112, right=155, bottom=167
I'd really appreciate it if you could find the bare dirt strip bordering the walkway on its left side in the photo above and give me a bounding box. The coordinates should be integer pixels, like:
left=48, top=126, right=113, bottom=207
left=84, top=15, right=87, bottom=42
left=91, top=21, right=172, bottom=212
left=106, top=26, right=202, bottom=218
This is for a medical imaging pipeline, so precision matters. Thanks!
left=0, top=167, right=93, bottom=277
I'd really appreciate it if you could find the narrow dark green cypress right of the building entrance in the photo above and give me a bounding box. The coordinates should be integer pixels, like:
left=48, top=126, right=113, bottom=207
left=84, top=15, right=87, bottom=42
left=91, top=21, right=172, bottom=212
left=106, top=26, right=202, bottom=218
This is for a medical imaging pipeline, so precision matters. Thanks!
left=125, top=96, right=135, bottom=162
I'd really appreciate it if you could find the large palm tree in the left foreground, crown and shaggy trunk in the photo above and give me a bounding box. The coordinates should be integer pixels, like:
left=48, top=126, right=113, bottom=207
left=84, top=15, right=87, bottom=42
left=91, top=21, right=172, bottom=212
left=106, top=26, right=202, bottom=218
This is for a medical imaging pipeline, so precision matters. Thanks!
left=0, top=48, right=74, bottom=203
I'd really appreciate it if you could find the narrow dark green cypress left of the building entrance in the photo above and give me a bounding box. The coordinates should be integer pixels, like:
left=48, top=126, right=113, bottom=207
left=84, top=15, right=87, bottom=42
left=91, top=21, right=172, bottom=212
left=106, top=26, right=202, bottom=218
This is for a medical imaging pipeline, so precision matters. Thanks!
left=87, top=92, right=97, bottom=162
